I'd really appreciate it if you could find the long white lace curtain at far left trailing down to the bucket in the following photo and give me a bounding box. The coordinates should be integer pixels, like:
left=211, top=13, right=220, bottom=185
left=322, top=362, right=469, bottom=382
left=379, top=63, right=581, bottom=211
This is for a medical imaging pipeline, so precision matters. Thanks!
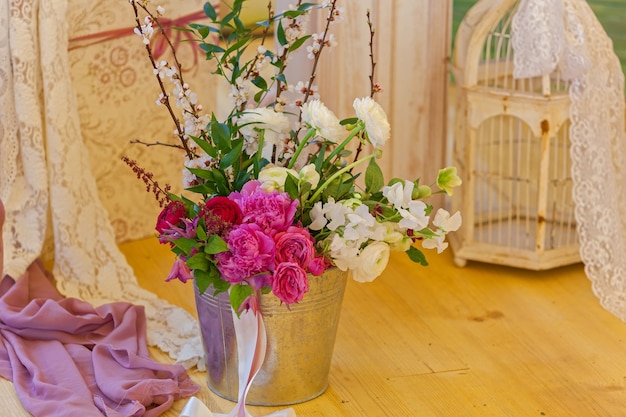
left=0, top=0, right=203, bottom=368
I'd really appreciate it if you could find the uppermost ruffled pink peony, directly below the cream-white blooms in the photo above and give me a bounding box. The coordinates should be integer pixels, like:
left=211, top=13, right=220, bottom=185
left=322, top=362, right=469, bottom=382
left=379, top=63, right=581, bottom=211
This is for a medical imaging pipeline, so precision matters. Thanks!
left=229, top=181, right=298, bottom=236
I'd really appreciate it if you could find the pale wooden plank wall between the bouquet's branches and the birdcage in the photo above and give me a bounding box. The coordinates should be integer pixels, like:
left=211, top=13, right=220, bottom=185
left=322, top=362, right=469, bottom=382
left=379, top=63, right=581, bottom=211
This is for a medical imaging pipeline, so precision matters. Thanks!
left=314, top=0, right=452, bottom=183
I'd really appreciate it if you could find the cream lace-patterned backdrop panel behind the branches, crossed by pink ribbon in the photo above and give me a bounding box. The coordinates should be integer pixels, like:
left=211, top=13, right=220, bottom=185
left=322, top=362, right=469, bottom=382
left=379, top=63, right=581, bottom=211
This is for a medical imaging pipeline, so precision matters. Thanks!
left=67, top=0, right=216, bottom=242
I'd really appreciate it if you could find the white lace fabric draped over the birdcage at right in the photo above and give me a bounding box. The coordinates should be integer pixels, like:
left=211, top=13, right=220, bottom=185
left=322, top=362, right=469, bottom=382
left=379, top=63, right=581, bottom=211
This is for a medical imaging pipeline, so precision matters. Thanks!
left=512, top=0, right=626, bottom=321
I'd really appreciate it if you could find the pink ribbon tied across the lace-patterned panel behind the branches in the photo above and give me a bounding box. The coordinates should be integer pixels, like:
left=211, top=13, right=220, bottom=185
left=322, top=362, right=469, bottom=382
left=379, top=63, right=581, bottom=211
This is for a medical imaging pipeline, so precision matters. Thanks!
left=69, top=5, right=211, bottom=64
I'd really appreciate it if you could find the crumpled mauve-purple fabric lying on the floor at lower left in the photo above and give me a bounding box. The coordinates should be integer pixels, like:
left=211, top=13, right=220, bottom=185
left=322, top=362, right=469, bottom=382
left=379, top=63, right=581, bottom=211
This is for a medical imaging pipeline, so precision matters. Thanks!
left=0, top=262, right=198, bottom=417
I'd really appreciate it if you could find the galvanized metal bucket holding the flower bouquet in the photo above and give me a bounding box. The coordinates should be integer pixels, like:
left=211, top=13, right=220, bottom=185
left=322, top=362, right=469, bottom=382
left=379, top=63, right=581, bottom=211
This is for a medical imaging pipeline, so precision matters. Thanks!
left=194, top=268, right=347, bottom=406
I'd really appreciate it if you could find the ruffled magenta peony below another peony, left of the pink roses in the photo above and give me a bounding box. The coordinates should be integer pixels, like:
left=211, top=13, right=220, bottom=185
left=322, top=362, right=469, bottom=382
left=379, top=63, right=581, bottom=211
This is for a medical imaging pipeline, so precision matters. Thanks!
left=215, top=223, right=274, bottom=288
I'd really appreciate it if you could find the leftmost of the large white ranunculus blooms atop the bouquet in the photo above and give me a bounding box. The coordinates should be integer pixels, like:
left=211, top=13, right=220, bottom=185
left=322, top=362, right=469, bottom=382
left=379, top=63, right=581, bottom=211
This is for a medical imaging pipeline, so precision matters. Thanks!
left=237, top=107, right=290, bottom=145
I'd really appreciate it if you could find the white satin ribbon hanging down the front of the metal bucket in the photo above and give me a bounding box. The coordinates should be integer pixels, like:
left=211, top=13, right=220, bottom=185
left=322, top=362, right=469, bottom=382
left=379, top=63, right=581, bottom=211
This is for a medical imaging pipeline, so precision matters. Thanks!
left=179, top=309, right=296, bottom=417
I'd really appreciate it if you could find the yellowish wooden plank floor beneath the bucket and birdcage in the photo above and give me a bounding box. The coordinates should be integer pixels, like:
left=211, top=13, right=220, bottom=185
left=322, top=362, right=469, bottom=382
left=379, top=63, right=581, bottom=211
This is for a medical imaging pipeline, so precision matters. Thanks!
left=0, top=239, right=626, bottom=417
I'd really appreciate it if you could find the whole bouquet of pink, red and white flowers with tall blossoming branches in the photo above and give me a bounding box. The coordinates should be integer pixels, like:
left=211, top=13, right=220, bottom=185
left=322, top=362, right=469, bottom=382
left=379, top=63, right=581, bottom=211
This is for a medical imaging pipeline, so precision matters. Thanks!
left=126, top=0, right=461, bottom=412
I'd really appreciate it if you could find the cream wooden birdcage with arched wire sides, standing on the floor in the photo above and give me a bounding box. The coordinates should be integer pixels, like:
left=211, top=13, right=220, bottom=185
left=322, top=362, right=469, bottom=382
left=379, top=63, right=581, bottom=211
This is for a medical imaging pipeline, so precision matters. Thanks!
left=451, top=0, right=580, bottom=270
